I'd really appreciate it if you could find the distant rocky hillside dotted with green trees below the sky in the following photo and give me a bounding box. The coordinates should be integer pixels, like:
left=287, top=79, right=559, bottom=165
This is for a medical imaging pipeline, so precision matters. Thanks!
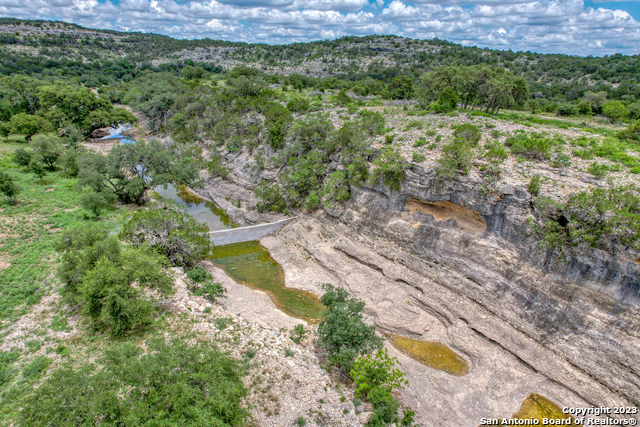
left=0, top=18, right=640, bottom=102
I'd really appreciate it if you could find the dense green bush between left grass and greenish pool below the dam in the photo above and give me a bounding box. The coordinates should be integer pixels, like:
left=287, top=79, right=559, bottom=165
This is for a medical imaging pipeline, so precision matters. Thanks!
left=55, top=224, right=173, bottom=336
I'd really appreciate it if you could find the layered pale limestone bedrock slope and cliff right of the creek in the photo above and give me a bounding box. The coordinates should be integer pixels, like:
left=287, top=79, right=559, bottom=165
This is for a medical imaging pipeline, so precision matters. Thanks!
left=200, top=155, right=640, bottom=426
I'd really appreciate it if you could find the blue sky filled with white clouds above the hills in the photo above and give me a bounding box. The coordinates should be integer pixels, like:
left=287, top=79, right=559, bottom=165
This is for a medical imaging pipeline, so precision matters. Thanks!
left=0, top=0, right=640, bottom=55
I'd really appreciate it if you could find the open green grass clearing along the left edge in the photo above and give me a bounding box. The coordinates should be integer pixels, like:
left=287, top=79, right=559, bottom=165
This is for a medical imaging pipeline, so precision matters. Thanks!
left=0, top=147, right=129, bottom=329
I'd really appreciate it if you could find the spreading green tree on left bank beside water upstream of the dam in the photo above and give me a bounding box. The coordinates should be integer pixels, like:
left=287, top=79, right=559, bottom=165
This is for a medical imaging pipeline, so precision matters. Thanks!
left=78, top=140, right=202, bottom=204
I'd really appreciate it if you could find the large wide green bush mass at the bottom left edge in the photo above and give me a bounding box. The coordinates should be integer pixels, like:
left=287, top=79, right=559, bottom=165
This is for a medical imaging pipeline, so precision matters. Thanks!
left=19, top=338, right=248, bottom=427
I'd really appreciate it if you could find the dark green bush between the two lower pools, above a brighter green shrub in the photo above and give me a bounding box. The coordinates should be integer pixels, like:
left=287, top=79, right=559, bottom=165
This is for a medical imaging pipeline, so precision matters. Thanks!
left=318, top=283, right=382, bottom=373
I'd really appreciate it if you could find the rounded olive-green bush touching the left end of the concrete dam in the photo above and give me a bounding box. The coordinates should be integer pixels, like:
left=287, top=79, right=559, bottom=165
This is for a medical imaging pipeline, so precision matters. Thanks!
left=119, top=200, right=211, bottom=267
